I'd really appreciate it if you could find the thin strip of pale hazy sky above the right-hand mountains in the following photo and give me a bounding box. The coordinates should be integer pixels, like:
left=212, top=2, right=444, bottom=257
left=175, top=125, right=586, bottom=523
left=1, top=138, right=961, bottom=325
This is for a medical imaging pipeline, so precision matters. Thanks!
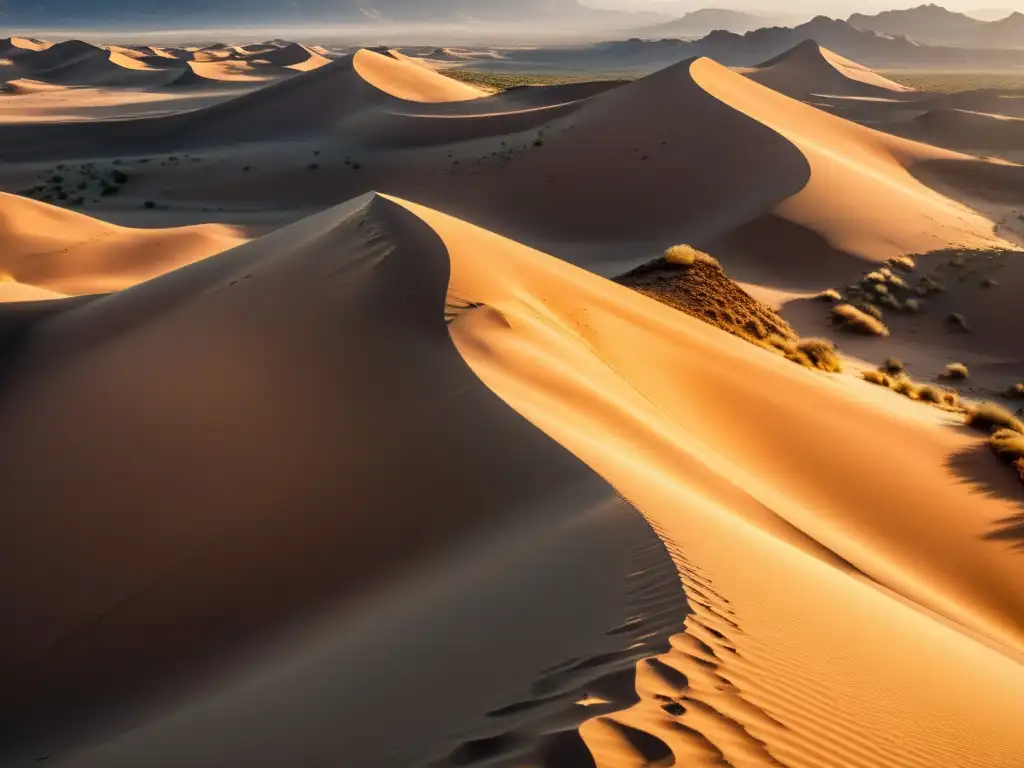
left=582, top=0, right=1024, bottom=16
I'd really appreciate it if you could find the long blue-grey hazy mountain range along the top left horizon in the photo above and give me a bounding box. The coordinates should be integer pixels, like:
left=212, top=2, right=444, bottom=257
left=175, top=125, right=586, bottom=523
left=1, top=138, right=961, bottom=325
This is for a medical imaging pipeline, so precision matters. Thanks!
left=0, top=0, right=667, bottom=29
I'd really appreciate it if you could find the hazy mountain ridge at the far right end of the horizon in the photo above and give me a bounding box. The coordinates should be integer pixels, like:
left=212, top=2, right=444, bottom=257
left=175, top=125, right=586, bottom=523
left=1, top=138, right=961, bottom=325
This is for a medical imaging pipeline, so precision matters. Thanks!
left=847, top=4, right=1024, bottom=48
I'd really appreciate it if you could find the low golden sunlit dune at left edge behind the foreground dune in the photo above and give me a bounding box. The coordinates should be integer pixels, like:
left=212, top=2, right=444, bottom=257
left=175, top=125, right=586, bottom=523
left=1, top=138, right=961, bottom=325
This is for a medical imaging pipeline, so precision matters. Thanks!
left=0, top=193, right=245, bottom=301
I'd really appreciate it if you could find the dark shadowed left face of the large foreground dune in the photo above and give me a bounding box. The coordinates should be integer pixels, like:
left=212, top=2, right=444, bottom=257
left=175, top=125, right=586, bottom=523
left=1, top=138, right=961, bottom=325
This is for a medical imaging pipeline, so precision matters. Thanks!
left=0, top=192, right=686, bottom=768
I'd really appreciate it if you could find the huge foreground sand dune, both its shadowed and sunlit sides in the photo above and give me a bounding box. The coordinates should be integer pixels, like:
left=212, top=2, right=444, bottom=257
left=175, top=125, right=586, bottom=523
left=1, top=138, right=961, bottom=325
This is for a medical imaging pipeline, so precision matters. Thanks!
left=0, top=188, right=1024, bottom=768
